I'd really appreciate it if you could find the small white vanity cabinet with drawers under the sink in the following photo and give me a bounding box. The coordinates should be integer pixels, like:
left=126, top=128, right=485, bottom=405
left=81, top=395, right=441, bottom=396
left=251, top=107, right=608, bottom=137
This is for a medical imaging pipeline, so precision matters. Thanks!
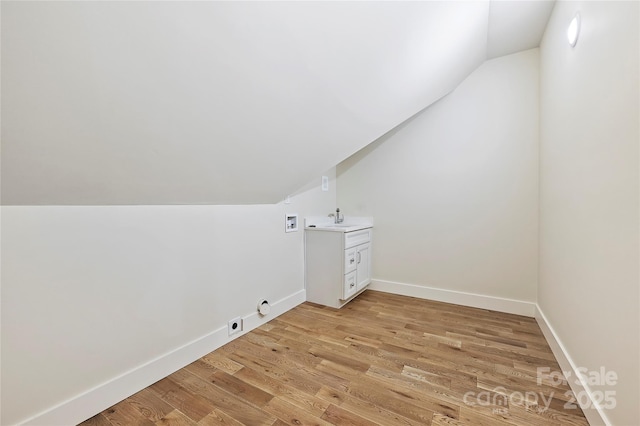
left=305, top=228, right=373, bottom=308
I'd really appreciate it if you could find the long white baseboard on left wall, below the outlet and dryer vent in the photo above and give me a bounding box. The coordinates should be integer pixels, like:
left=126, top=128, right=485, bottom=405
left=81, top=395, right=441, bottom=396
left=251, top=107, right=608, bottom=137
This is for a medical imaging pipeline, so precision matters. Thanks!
left=19, top=290, right=307, bottom=426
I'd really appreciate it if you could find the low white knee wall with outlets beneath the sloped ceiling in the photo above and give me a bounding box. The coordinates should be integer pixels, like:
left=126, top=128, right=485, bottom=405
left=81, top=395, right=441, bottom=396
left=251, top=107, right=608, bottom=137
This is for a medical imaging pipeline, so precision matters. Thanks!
left=0, top=171, right=335, bottom=425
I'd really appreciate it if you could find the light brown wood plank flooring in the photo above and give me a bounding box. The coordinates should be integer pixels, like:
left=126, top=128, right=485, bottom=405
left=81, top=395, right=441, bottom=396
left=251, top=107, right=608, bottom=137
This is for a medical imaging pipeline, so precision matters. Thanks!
left=77, top=290, right=588, bottom=426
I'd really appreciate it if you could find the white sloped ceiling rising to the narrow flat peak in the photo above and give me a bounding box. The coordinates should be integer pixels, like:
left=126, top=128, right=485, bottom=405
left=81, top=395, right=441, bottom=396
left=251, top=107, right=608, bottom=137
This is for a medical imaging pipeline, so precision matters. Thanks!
left=1, top=1, right=551, bottom=205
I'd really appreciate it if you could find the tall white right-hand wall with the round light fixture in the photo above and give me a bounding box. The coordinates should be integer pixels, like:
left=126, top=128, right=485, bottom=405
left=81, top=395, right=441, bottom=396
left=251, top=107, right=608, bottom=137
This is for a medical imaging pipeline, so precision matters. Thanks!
left=538, top=1, right=640, bottom=425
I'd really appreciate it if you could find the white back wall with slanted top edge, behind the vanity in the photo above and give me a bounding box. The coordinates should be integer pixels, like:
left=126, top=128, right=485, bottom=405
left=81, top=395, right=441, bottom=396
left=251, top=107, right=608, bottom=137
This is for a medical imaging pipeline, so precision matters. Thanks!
left=337, top=49, right=538, bottom=315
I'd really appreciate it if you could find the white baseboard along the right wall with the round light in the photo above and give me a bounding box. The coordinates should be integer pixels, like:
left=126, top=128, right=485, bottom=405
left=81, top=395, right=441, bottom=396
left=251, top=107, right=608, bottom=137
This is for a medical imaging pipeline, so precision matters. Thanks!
left=535, top=305, right=611, bottom=426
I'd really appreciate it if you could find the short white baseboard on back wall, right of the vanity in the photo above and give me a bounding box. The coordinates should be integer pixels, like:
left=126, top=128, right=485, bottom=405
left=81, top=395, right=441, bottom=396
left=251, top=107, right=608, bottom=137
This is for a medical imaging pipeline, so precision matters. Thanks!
left=369, top=280, right=536, bottom=317
